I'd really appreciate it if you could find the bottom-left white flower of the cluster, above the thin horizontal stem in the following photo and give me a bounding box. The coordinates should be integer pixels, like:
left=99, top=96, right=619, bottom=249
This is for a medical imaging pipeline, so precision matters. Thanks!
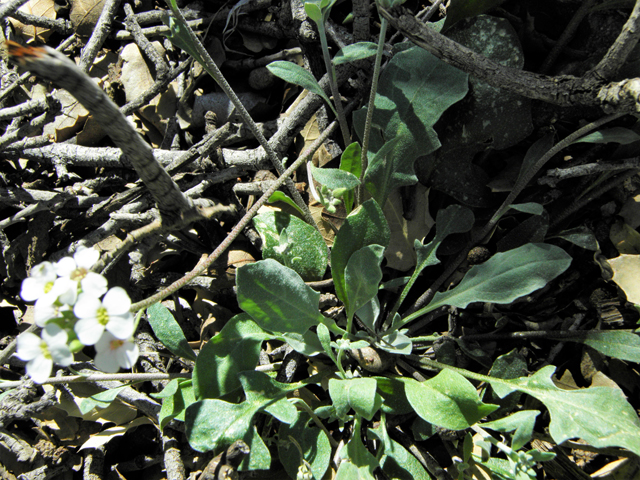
left=16, top=324, right=73, bottom=383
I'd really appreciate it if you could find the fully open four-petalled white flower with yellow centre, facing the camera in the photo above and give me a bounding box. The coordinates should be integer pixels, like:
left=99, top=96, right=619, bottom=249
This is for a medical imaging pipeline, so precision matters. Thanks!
left=73, top=287, right=134, bottom=345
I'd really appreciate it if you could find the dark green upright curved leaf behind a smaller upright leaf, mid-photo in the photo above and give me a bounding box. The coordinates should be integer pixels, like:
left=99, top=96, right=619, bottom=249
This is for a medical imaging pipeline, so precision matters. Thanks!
left=336, top=200, right=390, bottom=308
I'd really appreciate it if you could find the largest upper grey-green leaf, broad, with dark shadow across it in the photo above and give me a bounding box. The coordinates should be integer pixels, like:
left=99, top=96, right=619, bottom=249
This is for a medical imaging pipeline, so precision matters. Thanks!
left=353, top=47, right=468, bottom=205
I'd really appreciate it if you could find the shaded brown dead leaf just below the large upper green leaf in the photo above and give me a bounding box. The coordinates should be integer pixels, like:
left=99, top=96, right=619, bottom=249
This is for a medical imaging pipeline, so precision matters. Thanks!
left=384, top=184, right=435, bottom=272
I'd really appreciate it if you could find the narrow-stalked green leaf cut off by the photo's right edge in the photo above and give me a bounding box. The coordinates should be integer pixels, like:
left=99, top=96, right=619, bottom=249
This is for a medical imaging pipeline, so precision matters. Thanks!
left=549, top=330, right=640, bottom=363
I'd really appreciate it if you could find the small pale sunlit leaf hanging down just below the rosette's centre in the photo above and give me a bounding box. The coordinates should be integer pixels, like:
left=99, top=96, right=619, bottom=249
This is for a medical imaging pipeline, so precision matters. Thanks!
left=329, top=378, right=381, bottom=420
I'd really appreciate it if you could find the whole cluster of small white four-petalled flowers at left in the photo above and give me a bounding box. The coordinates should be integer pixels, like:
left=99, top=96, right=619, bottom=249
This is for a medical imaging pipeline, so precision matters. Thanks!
left=16, top=247, right=138, bottom=383
